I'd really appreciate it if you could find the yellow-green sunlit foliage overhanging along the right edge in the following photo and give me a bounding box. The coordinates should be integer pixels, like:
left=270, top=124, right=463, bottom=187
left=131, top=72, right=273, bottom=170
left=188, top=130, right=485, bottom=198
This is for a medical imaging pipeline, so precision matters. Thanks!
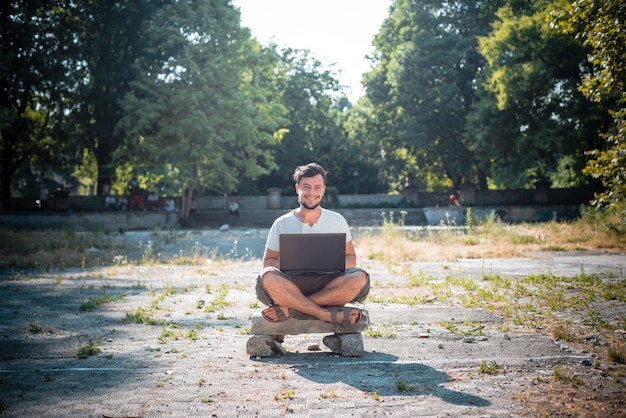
left=553, top=0, right=626, bottom=216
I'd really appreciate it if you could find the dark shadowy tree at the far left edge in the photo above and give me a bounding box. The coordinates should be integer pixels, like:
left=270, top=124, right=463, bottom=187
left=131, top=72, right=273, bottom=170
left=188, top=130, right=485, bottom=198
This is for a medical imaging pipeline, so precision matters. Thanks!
left=0, top=0, right=80, bottom=209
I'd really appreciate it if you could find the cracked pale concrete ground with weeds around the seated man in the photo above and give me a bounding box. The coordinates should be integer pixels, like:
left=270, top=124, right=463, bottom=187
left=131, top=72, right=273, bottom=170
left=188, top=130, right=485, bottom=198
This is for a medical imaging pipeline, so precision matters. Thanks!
left=0, top=231, right=626, bottom=417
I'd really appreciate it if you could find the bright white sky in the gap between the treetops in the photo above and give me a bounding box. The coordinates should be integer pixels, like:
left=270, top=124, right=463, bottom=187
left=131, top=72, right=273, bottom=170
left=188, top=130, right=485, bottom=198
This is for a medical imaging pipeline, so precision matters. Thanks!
left=233, top=0, right=392, bottom=103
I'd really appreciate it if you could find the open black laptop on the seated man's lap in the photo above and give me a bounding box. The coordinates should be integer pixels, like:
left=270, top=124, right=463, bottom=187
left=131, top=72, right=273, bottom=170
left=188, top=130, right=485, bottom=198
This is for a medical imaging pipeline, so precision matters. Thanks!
left=279, top=233, right=346, bottom=274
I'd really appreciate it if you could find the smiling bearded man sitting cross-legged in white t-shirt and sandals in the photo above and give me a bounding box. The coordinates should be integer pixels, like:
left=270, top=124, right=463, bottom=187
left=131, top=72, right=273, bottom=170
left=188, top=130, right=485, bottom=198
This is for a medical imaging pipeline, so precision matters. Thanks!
left=256, top=163, right=370, bottom=324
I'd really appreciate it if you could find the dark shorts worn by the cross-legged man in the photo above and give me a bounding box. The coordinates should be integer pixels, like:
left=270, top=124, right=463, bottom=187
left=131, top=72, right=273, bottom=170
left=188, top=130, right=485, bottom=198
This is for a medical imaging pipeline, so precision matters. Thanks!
left=256, top=267, right=370, bottom=305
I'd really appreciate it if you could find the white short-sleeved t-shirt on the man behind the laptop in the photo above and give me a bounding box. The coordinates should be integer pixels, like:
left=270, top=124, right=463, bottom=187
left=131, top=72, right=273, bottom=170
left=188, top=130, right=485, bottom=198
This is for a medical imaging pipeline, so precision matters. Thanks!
left=265, top=208, right=352, bottom=251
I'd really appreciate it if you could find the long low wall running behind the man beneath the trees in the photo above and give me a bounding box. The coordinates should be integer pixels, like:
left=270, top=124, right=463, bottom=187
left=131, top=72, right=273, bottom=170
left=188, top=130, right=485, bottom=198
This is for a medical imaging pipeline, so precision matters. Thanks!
left=0, top=205, right=580, bottom=231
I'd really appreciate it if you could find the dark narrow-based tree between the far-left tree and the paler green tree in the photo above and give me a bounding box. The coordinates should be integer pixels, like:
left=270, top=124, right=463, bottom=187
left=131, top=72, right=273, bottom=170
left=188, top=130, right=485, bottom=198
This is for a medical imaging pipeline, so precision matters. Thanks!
left=74, top=0, right=169, bottom=192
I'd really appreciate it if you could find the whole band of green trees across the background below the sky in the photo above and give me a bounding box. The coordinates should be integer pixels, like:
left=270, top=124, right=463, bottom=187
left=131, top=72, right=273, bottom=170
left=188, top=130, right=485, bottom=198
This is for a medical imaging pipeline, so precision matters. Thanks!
left=0, top=0, right=626, bottom=216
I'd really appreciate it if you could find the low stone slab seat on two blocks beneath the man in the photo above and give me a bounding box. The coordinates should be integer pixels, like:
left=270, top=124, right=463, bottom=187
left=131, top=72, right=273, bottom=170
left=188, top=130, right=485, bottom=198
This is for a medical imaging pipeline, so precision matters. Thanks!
left=246, top=306, right=370, bottom=357
